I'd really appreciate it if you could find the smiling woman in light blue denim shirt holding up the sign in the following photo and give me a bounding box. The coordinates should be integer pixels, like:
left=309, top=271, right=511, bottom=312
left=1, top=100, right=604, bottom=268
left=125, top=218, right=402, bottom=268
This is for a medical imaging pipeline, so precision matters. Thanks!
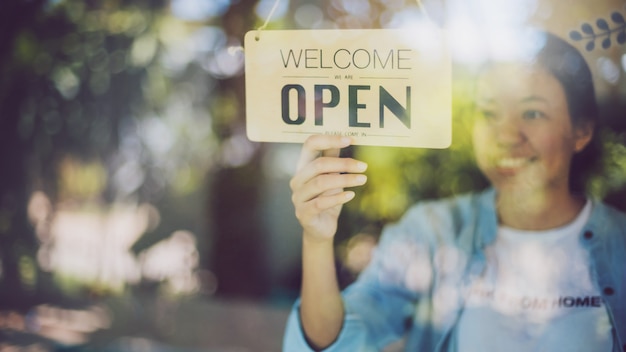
left=284, top=34, right=626, bottom=352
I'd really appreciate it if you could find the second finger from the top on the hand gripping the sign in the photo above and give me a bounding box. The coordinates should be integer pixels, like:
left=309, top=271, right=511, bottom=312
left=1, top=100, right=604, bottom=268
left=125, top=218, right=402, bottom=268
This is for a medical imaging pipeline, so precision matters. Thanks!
left=291, top=157, right=367, bottom=191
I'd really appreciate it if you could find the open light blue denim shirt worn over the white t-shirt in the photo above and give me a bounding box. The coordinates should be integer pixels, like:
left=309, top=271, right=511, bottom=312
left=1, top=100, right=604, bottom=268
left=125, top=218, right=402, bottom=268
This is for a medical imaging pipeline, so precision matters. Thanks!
left=283, top=189, right=626, bottom=352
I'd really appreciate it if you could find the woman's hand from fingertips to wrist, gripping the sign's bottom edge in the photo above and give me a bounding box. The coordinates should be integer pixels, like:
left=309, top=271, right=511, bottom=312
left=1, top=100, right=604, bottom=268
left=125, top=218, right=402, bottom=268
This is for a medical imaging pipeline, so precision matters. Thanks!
left=290, top=135, right=367, bottom=241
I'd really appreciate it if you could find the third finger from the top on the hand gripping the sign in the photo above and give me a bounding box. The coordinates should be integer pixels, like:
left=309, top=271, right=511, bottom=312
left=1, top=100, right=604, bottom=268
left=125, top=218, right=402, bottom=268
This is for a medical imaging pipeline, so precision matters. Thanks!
left=292, top=174, right=367, bottom=204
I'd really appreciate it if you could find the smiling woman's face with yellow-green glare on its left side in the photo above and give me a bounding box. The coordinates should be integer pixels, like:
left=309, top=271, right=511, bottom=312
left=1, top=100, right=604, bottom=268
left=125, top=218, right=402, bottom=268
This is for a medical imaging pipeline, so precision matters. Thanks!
left=473, top=64, right=591, bottom=194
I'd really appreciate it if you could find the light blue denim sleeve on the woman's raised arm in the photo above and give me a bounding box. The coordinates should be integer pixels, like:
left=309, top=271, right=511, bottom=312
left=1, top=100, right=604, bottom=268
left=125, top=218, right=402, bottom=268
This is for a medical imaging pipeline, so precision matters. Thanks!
left=283, top=205, right=431, bottom=352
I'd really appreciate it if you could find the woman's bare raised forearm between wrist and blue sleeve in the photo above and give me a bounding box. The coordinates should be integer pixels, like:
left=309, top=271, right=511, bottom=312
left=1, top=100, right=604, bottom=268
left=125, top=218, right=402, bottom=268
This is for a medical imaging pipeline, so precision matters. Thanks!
left=300, top=236, right=344, bottom=348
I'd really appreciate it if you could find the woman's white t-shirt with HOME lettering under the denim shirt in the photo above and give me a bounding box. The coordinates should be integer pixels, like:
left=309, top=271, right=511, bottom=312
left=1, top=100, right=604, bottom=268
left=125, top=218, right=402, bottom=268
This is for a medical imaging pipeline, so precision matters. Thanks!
left=453, top=201, right=612, bottom=352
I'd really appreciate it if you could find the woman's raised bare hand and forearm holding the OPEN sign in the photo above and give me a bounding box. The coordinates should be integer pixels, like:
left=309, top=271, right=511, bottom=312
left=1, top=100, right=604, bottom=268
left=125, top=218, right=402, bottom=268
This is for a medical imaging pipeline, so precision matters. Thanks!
left=290, top=135, right=367, bottom=350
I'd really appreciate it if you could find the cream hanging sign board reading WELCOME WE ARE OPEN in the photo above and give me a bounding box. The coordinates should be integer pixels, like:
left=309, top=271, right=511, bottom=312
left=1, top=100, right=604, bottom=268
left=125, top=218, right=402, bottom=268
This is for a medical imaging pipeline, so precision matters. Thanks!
left=245, top=28, right=452, bottom=148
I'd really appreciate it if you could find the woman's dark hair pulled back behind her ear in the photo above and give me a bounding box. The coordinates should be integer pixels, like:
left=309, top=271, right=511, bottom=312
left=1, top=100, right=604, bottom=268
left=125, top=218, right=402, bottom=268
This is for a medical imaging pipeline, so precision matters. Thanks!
left=535, top=32, right=602, bottom=193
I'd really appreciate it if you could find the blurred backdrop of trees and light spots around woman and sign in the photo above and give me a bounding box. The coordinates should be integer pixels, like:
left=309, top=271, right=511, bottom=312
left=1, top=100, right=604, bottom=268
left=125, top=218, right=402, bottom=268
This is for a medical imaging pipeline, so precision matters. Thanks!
left=0, top=0, right=626, bottom=351
